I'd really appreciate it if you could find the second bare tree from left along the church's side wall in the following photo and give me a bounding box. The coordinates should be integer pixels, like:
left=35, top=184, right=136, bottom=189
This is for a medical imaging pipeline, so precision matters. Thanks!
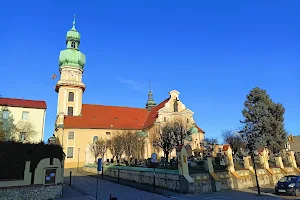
left=107, top=132, right=124, bottom=160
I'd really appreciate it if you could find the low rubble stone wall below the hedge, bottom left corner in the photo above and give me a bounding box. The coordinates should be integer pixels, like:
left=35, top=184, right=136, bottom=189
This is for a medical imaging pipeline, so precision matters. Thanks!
left=0, top=184, right=62, bottom=200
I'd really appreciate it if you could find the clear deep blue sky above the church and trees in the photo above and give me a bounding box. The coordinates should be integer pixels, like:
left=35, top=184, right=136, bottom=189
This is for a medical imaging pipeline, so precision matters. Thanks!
left=0, top=0, right=300, bottom=141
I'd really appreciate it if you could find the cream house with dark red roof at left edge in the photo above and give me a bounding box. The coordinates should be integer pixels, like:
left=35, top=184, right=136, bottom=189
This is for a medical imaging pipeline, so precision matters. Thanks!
left=0, top=98, right=47, bottom=143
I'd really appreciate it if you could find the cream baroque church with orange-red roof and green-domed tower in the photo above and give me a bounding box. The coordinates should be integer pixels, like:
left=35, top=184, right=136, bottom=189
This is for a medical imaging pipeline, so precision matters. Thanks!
left=54, top=19, right=204, bottom=168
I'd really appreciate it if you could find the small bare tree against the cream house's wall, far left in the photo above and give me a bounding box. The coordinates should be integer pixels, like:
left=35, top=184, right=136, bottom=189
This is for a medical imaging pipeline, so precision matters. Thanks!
left=14, top=121, right=37, bottom=142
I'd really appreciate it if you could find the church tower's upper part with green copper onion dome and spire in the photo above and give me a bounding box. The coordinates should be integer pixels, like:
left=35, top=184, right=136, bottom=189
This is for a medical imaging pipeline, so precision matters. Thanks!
left=55, top=16, right=85, bottom=116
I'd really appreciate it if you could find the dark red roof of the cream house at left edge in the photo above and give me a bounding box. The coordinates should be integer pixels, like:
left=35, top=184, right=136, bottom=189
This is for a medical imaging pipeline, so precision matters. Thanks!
left=0, top=98, right=47, bottom=109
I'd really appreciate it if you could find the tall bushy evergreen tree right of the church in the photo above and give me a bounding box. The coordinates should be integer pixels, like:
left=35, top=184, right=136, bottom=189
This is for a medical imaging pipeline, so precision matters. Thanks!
left=241, top=87, right=287, bottom=154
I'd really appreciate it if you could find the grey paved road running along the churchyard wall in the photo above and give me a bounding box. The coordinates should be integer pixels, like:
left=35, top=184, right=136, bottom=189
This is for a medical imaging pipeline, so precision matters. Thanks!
left=61, top=170, right=300, bottom=200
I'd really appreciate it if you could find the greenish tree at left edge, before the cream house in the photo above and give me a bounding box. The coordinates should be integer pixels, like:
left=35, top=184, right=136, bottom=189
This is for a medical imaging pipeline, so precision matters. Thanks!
left=0, top=107, right=16, bottom=141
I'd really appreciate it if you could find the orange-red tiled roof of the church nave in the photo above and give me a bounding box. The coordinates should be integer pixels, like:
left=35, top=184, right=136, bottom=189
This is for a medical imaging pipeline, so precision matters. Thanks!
left=64, top=98, right=204, bottom=133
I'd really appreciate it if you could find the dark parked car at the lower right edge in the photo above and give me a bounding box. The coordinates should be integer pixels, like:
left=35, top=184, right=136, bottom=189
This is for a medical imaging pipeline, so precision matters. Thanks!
left=275, top=175, right=300, bottom=196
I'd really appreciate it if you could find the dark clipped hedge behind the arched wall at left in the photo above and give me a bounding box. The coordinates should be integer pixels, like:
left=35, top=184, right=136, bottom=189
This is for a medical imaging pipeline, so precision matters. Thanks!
left=0, top=141, right=64, bottom=180
